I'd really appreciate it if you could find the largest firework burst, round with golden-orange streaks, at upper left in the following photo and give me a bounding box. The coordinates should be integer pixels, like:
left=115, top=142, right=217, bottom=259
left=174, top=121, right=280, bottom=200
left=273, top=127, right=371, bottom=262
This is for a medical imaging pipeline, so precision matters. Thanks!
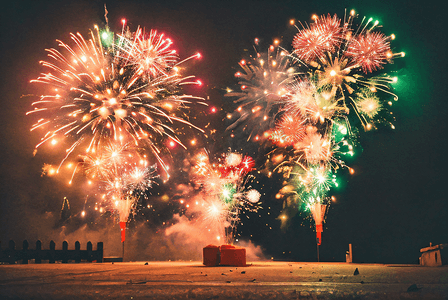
left=27, top=23, right=207, bottom=177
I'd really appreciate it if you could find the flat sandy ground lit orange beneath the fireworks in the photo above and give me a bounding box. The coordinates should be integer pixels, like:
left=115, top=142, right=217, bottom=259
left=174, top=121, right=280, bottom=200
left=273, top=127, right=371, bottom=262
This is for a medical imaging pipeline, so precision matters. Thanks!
left=0, top=261, right=448, bottom=299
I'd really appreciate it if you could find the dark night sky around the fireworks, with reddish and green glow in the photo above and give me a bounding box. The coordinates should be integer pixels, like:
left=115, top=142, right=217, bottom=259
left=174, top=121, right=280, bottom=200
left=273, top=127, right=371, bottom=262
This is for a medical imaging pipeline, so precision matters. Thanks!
left=0, top=0, right=448, bottom=263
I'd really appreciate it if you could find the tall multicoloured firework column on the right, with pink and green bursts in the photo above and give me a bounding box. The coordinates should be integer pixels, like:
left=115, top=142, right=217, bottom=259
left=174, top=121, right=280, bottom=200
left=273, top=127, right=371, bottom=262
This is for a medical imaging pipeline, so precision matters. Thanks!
left=228, top=10, right=404, bottom=241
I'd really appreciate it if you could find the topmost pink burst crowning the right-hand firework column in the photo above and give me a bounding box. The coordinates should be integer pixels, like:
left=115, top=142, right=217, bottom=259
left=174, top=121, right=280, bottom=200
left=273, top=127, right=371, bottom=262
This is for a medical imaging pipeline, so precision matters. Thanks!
left=292, top=15, right=343, bottom=62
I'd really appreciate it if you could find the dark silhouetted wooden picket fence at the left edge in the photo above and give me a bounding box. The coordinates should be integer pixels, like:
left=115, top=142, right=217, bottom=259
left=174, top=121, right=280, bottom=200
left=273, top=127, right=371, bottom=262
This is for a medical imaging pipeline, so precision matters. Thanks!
left=0, top=240, right=103, bottom=264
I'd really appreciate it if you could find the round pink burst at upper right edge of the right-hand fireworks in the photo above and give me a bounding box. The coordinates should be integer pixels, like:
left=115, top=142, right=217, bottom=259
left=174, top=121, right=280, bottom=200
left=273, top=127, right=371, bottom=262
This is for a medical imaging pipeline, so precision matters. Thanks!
left=345, top=32, right=391, bottom=74
